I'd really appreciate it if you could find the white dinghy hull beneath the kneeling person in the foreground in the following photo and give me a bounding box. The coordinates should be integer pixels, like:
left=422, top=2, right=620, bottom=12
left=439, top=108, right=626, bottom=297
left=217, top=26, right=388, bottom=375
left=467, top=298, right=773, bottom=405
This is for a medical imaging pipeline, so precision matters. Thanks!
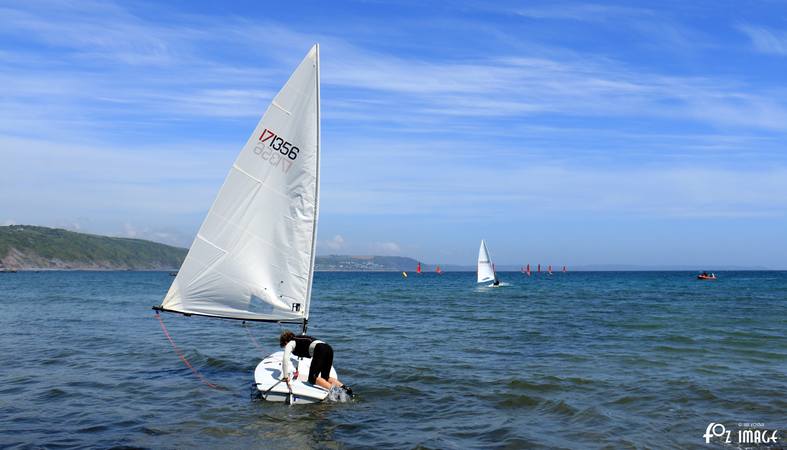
left=254, top=351, right=338, bottom=405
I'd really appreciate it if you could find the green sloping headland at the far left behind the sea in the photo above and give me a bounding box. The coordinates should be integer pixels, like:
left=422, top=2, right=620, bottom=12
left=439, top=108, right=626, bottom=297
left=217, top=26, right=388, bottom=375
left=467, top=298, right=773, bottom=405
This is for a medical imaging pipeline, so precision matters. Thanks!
left=0, top=225, right=186, bottom=270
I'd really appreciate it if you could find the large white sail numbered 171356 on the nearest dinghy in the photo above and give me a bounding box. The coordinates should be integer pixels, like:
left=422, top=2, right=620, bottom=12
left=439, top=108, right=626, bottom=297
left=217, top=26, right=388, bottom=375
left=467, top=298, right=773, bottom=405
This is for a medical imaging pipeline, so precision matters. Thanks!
left=161, top=45, right=320, bottom=322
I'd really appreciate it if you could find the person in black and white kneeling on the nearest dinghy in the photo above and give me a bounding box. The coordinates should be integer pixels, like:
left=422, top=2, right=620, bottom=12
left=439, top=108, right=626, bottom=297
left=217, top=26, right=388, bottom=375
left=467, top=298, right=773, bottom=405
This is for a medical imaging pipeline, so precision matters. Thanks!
left=279, top=330, right=353, bottom=396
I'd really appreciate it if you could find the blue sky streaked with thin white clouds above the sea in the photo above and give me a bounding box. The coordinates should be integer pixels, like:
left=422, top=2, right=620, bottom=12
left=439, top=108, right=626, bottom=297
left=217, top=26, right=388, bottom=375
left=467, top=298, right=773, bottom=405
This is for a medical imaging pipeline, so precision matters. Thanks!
left=0, top=0, right=787, bottom=269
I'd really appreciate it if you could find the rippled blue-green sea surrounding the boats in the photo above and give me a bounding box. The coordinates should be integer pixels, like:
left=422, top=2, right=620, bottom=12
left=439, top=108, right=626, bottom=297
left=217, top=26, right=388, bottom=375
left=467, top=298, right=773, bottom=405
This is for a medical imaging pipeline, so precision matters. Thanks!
left=0, top=271, right=787, bottom=449
